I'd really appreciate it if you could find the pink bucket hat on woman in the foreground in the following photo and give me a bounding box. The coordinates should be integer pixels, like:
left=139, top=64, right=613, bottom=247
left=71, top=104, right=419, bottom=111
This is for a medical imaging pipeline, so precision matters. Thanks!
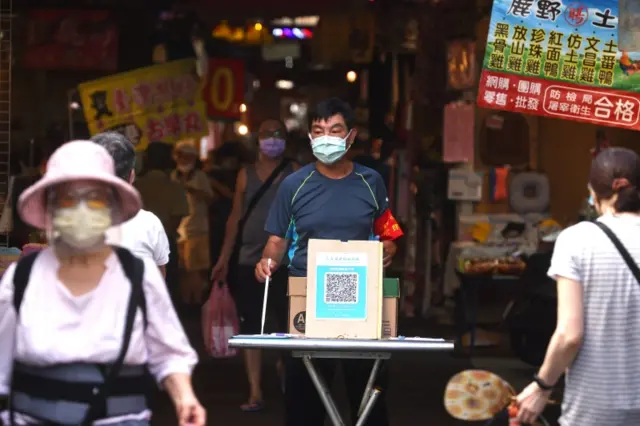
left=18, top=141, right=142, bottom=229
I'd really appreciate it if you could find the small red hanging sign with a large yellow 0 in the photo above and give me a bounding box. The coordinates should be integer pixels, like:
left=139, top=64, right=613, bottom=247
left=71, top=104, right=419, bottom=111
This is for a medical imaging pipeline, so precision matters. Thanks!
left=202, top=58, right=245, bottom=121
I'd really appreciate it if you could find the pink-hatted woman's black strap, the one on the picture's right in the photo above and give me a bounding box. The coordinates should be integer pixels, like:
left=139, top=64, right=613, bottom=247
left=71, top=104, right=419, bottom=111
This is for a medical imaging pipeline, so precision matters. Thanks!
left=81, top=247, right=146, bottom=426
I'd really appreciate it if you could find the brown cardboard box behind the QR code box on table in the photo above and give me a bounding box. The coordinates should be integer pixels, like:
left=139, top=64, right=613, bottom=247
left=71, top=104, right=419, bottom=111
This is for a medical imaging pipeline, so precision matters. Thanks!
left=288, top=277, right=400, bottom=339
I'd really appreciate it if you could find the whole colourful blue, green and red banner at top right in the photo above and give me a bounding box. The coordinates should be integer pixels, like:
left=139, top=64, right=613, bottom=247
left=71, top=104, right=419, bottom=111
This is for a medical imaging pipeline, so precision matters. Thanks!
left=478, top=0, right=640, bottom=130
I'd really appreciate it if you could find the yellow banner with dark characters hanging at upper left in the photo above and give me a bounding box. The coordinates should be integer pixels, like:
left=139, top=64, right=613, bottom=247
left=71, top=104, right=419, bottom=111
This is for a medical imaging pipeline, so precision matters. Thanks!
left=78, top=59, right=208, bottom=151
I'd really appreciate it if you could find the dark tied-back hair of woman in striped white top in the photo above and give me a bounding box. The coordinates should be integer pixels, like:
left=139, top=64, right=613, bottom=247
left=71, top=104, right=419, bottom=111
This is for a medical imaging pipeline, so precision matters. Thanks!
left=589, top=148, right=640, bottom=213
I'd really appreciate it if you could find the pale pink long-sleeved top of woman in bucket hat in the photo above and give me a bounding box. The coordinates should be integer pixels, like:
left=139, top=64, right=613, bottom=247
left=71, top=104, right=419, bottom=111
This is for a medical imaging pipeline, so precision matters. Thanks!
left=0, top=248, right=198, bottom=423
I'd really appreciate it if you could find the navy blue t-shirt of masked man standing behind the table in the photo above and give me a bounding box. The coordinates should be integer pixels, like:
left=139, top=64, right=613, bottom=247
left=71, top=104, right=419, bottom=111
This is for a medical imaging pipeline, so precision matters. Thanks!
left=265, top=163, right=389, bottom=277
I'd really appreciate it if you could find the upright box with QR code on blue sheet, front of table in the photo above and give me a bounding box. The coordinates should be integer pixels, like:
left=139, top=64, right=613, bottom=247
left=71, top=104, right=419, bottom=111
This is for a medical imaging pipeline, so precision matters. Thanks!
left=305, top=239, right=383, bottom=339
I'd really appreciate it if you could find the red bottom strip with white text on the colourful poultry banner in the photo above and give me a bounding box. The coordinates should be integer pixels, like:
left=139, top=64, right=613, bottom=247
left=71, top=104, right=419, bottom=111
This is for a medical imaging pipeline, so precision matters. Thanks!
left=478, top=70, right=640, bottom=130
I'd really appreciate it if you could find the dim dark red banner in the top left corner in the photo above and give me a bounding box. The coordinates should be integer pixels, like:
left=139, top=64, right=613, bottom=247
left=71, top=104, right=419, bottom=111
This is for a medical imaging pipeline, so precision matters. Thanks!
left=23, top=10, right=118, bottom=71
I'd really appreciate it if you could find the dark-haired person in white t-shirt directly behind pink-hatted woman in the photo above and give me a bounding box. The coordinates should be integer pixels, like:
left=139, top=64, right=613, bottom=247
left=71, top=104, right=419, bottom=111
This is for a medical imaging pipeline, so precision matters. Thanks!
left=91, top=132, right=170, bottom=276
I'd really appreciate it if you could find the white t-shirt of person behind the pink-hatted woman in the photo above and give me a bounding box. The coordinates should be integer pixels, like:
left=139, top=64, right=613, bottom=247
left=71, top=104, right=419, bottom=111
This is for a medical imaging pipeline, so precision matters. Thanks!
left=107, top=210, right=170, bottom=266
